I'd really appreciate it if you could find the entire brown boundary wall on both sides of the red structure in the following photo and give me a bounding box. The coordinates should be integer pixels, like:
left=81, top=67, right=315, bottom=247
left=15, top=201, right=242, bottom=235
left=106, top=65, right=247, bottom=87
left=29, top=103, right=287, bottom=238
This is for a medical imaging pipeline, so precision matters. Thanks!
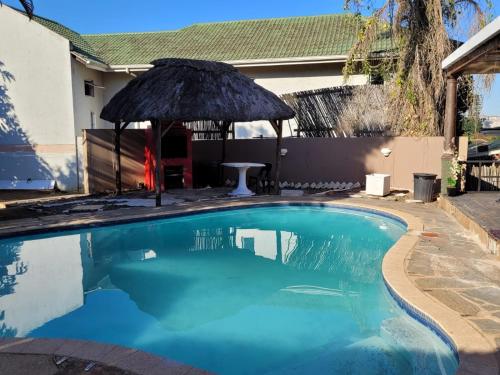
left=84, top=129, right=452, bottom=193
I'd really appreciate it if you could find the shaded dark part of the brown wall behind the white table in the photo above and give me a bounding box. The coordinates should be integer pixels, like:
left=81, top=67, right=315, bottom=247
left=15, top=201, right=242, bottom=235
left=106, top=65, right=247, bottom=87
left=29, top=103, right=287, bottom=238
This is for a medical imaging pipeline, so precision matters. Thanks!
left=193, top=137, right=390, bottom=188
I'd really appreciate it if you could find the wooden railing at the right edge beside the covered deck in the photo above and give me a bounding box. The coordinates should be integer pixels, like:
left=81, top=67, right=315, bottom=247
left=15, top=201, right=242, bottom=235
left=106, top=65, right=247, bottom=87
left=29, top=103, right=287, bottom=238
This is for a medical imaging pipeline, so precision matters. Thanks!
left=462, top=160, right=500, bottom=191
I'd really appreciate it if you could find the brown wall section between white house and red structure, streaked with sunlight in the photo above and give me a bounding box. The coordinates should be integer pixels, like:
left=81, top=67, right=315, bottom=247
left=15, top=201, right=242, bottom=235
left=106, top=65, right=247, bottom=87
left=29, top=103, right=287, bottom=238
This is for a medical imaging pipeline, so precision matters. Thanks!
left=83, top=129, right=146, bottom=193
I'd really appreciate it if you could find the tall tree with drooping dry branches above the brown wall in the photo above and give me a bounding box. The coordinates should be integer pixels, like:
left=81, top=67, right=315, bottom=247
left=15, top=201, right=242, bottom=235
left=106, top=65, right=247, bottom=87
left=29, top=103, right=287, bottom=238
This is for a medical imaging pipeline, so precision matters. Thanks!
left=344, top=0, right=492, bottom=135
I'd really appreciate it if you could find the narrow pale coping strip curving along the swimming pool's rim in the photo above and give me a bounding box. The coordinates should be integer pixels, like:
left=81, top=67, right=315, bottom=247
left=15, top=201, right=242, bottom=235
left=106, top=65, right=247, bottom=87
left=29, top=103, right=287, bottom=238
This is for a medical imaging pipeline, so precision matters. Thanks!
left=0, top=197, right=500, bottom=375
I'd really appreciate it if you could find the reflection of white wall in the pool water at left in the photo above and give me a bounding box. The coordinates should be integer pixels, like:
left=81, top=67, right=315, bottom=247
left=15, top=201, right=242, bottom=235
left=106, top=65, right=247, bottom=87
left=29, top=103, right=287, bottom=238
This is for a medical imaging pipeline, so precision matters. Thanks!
left=0, top=234, right=83, bottom=337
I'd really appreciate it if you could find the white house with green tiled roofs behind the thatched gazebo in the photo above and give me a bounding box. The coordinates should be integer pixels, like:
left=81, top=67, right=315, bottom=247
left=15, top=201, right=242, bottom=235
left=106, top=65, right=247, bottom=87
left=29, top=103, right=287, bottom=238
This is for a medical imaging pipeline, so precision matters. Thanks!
left=0, top=5, right=390, bottom=190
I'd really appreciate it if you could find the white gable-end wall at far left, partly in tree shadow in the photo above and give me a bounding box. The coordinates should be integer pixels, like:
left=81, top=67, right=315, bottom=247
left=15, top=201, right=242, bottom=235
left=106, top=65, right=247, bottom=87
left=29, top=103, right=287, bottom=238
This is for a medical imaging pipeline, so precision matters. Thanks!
left=0, top=6, right=76, bottom=190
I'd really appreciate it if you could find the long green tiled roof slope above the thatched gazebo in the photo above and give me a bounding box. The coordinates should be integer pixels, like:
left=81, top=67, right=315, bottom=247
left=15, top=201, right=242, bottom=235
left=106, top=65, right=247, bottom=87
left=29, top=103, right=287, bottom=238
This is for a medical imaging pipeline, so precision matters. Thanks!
left=83, top=14, right=390, bottom=65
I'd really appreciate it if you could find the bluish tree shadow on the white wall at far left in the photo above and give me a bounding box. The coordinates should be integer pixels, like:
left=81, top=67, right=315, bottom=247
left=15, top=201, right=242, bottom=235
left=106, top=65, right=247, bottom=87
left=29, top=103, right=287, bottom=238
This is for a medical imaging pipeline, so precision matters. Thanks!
left=0, top=61, right=77, bottom=189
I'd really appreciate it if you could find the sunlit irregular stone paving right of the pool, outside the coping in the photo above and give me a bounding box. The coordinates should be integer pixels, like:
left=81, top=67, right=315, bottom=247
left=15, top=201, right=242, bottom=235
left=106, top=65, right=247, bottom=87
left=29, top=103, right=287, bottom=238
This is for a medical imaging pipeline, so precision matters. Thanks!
left=356, top=199, right=500, bottom=374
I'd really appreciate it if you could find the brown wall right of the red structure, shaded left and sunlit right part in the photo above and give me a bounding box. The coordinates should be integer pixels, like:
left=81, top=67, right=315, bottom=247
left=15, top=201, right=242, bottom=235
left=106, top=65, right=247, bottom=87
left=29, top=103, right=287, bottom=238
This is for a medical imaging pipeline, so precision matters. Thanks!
left=193, top=137, right=443, bottom=190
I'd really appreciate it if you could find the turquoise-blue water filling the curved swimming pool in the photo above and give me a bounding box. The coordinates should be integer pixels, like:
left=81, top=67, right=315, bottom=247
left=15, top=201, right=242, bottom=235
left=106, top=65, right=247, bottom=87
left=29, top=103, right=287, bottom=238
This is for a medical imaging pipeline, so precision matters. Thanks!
left=0, top=206, right=457, bottom=375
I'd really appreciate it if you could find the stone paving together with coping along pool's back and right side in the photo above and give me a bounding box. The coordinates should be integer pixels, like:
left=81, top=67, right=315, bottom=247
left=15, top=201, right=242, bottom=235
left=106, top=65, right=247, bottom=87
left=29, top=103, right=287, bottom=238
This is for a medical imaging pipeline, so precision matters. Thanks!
left=0, top=196, right=500, bottom=374
